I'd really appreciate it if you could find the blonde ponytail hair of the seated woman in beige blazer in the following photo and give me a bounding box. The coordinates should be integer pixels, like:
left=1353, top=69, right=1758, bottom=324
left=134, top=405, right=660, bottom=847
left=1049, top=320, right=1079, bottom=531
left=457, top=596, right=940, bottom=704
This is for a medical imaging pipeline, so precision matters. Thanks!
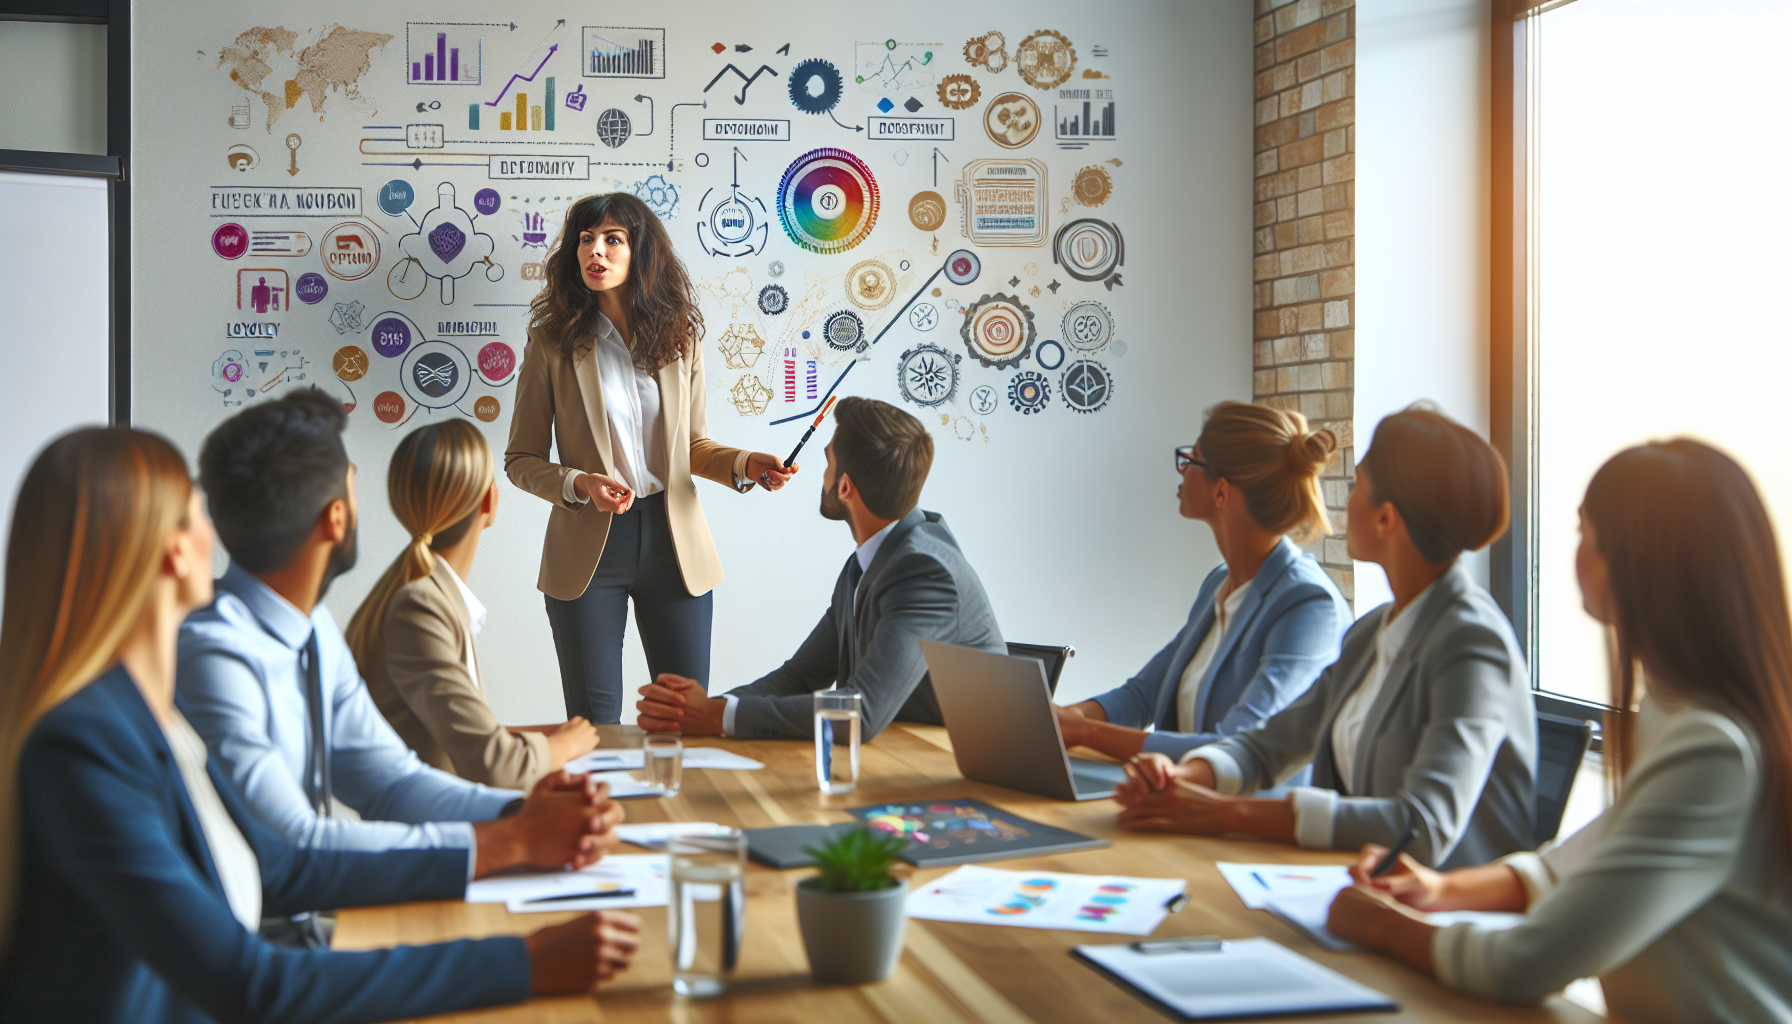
left=344, top=420, right=496, bottom=676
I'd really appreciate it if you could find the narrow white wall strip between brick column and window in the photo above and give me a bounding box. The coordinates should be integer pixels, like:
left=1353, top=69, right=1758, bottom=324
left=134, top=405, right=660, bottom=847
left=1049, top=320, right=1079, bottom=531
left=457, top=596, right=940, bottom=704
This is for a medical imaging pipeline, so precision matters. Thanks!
left=1355, top=0, right=1493, bottom=615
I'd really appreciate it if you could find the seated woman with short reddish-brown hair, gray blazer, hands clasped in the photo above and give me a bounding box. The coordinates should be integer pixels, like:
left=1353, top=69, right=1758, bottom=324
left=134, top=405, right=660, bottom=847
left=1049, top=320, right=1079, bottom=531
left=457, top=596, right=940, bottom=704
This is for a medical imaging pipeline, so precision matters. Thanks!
left=1116, top=407, right=1538, bottom=866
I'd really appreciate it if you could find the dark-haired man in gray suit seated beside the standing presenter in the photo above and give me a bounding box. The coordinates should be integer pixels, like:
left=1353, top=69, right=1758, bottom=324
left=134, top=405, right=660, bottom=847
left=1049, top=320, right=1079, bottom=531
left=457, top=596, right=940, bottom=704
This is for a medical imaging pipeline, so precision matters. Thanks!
left=634, top=398, right=1007, bottom=741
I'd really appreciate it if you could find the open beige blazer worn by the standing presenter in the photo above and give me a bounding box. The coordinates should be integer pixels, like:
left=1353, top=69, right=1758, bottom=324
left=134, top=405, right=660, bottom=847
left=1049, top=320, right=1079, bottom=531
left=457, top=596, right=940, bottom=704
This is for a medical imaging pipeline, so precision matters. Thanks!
left=504, top=332, right=747, bottom=601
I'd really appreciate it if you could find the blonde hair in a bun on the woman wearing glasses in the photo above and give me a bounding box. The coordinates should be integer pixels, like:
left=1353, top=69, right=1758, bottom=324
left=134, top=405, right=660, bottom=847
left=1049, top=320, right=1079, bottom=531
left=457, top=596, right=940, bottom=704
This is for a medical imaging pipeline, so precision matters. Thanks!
left=1199, top=402, right=1339, bottom=543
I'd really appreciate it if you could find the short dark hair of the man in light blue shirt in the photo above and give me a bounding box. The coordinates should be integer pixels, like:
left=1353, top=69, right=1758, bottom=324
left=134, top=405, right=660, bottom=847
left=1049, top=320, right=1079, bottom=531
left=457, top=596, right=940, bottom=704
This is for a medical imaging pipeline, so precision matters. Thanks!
left=199, top=387, right=348, bottom=574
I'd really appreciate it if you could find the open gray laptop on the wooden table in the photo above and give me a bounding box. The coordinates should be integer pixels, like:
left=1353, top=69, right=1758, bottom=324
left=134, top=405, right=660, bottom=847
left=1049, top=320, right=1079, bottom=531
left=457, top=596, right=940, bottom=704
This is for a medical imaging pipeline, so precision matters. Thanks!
left=921, top=640, right=1125, bottom=800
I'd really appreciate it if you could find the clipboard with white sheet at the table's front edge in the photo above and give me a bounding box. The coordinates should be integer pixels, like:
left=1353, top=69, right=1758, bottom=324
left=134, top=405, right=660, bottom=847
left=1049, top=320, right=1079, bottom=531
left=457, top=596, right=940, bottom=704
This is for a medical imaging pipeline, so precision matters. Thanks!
left=1077, top=938, right=1400, bottom=1020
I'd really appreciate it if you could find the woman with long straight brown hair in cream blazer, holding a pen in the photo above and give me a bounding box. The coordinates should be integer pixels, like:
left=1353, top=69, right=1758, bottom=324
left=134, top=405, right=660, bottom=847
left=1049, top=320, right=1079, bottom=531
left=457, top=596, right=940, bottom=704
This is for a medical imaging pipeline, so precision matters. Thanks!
left=1330, top=439, right=1792, bottom=1022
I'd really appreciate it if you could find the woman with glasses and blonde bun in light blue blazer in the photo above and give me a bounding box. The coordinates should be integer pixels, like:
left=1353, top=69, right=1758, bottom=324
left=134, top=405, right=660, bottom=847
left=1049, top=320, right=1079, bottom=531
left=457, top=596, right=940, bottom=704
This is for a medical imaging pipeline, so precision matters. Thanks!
left=1057, top=402, right=1351, bottom=760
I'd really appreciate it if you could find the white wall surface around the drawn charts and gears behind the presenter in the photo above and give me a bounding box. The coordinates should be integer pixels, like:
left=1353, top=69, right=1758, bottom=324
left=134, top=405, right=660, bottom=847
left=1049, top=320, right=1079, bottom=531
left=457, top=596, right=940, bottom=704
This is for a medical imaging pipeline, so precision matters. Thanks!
left=133, top=0, right=1251, bottom=723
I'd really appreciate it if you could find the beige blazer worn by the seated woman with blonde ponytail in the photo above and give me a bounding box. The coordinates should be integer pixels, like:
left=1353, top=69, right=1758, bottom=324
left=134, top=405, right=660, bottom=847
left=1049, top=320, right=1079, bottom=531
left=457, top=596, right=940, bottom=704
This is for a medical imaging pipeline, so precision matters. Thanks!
left=360, top=558, right=552, bottom=791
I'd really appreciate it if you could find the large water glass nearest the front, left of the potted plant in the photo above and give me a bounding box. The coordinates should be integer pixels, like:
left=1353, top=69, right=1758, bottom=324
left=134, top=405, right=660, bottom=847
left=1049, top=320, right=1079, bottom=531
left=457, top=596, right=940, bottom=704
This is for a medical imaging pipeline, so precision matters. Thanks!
left=667, top=829, right=747, bottom=995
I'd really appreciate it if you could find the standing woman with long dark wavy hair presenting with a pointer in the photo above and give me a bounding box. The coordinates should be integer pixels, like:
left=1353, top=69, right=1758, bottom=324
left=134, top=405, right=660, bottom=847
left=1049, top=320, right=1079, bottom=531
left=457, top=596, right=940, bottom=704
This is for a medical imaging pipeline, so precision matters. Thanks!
left=504, top=192, right=796, bottom=725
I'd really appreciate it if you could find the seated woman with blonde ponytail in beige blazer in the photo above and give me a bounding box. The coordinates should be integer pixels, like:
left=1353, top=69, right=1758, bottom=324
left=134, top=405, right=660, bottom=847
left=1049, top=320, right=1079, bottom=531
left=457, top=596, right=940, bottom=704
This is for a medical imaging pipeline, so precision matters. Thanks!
left=346, top=420, right=597, bottom=791
